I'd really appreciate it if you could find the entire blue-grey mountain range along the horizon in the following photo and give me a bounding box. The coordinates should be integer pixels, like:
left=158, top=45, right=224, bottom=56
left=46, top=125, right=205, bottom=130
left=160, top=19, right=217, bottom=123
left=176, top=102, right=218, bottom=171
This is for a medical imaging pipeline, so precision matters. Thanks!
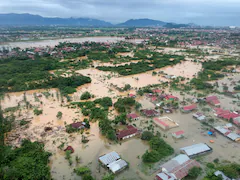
left=0, top=13, right=189, bottom=27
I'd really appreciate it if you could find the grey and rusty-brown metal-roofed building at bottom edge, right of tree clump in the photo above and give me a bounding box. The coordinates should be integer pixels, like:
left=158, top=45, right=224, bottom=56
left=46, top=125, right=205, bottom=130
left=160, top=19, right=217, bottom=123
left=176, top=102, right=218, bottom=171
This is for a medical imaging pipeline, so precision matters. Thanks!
left=156, top=154, right=200, bottom=180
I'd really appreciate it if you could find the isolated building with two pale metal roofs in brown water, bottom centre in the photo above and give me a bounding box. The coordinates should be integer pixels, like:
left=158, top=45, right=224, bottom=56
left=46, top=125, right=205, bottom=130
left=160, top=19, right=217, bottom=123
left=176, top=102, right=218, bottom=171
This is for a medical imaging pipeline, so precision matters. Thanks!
left=98, top=151, right=128, bottom=174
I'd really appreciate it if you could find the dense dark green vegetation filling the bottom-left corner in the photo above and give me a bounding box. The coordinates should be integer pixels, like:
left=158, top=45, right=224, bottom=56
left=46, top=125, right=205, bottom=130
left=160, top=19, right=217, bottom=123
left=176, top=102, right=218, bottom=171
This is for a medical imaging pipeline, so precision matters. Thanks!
left=0, top=140, right=51, bottom=180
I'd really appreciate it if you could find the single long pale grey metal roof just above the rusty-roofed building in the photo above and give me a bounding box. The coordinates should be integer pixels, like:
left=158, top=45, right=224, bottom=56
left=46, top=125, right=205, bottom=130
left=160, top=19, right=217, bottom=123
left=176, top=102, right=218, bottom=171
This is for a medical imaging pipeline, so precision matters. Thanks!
left=180, top=143, right=211, bottom=156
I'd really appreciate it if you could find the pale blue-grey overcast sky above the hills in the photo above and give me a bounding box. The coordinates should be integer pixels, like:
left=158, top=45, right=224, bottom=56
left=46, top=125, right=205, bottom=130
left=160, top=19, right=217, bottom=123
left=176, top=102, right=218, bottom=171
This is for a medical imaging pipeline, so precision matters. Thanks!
left=0, top=0, right=240, bottom=26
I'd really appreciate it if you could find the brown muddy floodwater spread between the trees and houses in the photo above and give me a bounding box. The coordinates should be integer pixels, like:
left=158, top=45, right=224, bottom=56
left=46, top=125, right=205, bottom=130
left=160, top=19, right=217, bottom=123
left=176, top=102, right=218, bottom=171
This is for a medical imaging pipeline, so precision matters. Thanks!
left=1, top=37, right=240, bottom=180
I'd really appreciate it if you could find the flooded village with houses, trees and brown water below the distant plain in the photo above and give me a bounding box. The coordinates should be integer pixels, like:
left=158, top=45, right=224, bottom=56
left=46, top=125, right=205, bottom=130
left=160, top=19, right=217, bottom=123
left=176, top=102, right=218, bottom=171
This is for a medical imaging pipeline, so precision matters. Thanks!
left=0, top=29, right=240, bottom=180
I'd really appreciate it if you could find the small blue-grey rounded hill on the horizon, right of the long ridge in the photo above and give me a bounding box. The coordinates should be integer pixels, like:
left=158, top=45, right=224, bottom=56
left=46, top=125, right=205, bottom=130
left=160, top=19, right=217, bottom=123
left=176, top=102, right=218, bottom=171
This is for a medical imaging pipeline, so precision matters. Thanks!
left=117, top=19, right=166, bottom=27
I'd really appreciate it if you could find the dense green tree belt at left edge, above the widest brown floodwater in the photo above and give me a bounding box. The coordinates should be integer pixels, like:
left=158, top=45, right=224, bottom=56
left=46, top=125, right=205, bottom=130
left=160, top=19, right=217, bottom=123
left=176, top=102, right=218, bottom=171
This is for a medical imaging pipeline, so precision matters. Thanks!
left=0, top=57, right=91, bottom=94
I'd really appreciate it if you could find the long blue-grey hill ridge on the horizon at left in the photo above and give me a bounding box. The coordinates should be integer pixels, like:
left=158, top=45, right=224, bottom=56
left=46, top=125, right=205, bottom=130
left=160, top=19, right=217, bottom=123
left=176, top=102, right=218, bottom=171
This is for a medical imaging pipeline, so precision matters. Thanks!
left=0, top=14, right=112, bottom=26
